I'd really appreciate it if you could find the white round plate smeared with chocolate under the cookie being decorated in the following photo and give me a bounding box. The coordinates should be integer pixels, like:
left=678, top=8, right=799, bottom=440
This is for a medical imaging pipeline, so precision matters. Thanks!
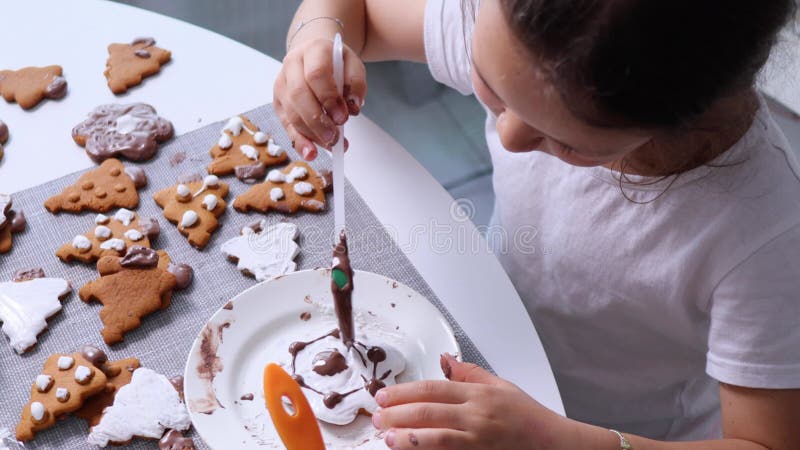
left=184, top=269, right=459, bottom=450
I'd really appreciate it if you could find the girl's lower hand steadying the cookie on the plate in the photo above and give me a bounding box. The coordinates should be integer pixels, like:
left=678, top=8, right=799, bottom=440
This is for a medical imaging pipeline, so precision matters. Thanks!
left=372, top=354, right=569, bottom=450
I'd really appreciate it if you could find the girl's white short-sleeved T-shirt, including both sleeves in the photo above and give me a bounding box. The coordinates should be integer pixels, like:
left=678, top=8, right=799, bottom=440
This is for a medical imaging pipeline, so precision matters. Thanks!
left=425, top=0, right=800, bottom=440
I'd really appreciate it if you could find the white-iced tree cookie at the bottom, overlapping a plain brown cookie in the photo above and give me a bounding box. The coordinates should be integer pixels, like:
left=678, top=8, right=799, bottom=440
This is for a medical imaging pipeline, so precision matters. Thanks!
left=87, top=367, right=192, bottom=447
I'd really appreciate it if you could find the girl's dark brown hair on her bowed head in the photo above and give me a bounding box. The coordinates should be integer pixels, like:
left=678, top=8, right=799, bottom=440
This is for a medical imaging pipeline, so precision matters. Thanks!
left=500, top=0, right=795, bottom=128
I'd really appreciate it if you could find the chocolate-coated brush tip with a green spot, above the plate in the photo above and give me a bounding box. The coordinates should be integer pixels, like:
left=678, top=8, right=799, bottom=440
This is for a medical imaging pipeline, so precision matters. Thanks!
left=331, top=230, right=355, bottom=349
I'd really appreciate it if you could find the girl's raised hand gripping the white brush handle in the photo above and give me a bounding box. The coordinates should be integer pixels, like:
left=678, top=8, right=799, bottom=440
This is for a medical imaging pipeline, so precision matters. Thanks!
left=273, top=39, right=367, bottom=160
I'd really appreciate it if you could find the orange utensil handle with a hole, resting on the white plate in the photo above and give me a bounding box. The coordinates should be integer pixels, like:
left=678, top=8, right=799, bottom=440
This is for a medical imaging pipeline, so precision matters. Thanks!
left=264, top=363, right=325, bottom=450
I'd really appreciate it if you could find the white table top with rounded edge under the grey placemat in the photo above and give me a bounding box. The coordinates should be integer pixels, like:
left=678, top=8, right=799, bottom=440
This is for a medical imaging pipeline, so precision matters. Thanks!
left=0, top=0, right=563, bottom=414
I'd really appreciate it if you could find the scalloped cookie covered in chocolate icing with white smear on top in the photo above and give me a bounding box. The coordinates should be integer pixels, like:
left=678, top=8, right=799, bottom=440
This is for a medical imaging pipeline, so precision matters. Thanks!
left=72, top=103, right=175, bottom=163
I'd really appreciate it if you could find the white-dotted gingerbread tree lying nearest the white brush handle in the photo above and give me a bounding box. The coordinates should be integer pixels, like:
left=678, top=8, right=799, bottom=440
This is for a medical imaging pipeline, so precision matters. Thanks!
left=233, top=161, right=332, bottom=214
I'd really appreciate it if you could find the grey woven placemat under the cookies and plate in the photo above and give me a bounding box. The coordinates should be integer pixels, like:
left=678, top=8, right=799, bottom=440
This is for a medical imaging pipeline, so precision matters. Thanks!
left=0, top=105, right=488, bottom=449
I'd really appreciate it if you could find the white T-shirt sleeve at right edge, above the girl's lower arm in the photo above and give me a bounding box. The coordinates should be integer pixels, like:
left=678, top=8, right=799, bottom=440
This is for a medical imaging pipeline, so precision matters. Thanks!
left=706, top=225, right=800, bottom=389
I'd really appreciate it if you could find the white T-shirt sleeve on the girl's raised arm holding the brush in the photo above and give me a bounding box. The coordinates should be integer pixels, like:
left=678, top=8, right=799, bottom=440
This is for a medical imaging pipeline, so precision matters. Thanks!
left=425, top=0, right=472, bottom=95
